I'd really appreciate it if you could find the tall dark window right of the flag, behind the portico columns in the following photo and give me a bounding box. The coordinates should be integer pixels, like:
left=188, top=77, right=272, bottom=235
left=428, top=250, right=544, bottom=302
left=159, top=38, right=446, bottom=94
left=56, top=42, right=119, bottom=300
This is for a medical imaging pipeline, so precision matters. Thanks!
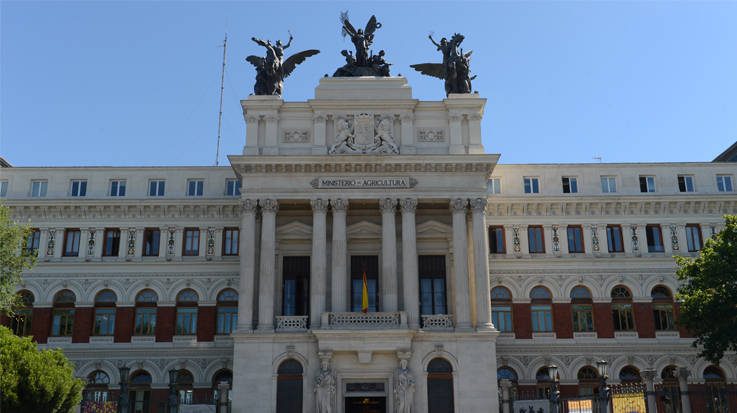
left=418, top=255, right=448, bottom=314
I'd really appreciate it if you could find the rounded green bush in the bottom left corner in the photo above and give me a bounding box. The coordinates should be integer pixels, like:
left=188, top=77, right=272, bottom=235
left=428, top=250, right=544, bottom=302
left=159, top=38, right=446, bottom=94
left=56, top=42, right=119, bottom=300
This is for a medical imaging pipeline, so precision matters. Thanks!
left=0, top=327, right=84, bottom=413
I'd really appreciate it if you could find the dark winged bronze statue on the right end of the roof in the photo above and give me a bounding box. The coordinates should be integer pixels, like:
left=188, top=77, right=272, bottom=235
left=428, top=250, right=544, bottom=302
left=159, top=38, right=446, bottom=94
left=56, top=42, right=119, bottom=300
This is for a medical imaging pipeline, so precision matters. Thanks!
left=410, top=33, right=476, bottom=95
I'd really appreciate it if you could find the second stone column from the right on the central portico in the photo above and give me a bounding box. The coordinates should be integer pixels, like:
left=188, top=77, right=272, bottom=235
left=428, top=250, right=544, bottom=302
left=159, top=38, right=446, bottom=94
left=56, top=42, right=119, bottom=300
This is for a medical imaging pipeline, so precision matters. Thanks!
left=450, top=198, right=471, bottom=330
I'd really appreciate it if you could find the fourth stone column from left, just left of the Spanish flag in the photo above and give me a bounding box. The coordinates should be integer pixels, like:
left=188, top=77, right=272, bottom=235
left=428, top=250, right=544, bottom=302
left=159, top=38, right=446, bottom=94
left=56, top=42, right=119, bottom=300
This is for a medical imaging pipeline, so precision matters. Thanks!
left=330, top=198, right=348, bottom=312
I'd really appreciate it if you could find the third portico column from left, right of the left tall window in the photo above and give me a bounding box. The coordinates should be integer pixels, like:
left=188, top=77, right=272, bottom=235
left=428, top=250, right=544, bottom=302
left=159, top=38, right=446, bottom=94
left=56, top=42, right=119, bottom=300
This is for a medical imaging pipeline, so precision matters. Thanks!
left=310, top=199, right=328, bottom=329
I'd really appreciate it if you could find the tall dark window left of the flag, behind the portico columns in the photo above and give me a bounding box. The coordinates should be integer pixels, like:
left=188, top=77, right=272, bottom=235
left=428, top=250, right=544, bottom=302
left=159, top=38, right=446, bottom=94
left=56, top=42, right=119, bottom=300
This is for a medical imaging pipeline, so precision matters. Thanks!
left=282, top=257, right=310, bottom=316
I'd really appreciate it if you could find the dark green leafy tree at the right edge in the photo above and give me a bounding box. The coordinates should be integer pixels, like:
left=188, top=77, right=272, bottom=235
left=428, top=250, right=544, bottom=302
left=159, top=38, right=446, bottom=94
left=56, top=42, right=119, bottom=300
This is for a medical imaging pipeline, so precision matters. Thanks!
left=676, top=215, right=737, bottom=363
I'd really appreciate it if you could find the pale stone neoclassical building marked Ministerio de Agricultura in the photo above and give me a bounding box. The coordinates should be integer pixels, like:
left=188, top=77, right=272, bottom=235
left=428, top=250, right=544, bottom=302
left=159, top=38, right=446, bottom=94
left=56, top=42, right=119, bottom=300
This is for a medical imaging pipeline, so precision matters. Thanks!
left=0, top=77, right=737, bottom=413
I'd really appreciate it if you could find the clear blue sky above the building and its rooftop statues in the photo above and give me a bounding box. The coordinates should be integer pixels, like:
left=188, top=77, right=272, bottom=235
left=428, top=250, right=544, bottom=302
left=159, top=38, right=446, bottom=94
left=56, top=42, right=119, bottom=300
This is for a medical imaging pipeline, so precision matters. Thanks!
left=0, top=1, right=737, bottom=166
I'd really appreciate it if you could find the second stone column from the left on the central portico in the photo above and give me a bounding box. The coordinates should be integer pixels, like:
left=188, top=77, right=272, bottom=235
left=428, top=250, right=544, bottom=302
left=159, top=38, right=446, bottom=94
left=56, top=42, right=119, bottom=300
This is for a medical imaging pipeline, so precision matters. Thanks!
left=258, top=199, right=279, bottom=330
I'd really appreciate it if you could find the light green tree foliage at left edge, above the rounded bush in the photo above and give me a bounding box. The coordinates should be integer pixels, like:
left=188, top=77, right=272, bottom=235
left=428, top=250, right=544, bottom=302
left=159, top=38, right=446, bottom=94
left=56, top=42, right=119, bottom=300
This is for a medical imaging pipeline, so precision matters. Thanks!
left=0, top=205, right=36, bottom=313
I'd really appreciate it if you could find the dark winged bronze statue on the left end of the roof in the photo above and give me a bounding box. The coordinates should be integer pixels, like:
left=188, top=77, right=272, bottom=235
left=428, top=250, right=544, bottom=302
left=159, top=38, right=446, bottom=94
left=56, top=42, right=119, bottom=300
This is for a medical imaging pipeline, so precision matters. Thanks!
left=246, top=34, right=320, bottom=96
